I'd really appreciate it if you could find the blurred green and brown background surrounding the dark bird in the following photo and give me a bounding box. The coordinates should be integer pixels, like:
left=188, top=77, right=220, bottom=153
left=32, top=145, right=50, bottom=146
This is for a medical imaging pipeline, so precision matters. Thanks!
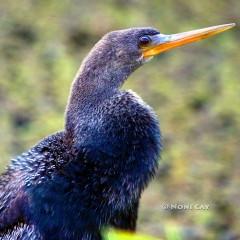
left=0, top=0, right=240, bottom=240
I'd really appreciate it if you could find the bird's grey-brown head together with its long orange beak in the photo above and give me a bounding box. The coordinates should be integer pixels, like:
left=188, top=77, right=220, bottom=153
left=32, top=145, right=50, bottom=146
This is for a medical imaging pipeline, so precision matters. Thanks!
left=103, top=23, right=235, bottom=64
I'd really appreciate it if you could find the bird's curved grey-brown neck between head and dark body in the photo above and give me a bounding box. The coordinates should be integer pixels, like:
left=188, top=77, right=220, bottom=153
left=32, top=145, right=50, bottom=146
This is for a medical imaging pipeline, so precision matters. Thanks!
left=65, top=41, right=142, bottom=137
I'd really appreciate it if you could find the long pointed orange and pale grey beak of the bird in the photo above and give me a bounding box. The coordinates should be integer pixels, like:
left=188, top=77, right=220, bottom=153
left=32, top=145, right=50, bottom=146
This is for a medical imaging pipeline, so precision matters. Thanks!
left=142, top=23, right=236, bottom=58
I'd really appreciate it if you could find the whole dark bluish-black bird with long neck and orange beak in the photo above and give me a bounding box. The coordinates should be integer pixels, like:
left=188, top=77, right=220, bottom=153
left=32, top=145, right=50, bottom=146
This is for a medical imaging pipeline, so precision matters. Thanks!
left=0, top=24, right=234, bottom=240
